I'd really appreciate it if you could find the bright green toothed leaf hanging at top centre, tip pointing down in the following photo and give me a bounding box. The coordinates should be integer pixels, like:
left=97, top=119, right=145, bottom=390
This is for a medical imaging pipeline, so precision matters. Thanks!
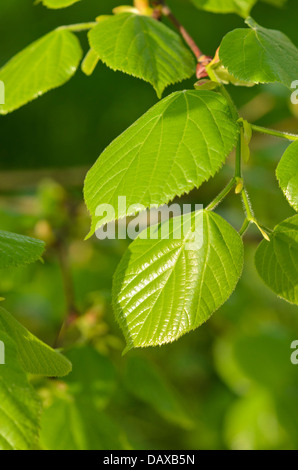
left=89, top=13, right=195, bottom=97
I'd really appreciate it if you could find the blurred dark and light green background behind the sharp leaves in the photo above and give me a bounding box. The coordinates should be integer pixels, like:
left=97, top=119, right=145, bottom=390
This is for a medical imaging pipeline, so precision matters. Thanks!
left=0, top=0, right=298, bottom=450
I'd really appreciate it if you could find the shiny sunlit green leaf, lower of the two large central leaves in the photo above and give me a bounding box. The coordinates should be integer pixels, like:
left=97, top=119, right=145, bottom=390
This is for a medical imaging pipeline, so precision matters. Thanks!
left=113, top=211, right=243, bottom=351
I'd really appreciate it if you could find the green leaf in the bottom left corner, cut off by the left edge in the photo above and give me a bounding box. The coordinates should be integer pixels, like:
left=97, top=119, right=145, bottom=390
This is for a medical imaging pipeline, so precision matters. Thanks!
left=0, top=331, right=40, bottom=450
